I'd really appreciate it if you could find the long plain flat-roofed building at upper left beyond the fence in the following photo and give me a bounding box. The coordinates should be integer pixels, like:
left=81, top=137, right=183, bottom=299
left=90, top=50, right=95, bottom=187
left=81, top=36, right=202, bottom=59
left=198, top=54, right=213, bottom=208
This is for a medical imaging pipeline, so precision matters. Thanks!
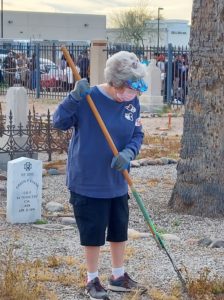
left=0, top=11, right=106, bottom=41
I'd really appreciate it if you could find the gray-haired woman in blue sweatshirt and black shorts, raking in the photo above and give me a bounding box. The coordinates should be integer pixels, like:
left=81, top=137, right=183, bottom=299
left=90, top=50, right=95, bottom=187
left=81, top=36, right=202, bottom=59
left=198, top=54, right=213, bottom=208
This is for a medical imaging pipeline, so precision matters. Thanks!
left=54, top=51, right=147, bottom=299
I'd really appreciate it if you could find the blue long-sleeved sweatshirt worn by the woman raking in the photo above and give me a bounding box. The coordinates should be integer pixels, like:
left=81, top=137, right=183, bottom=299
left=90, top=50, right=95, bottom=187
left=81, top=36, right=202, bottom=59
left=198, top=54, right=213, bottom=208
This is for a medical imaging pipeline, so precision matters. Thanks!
left=53, top=86, right=143, bottom=198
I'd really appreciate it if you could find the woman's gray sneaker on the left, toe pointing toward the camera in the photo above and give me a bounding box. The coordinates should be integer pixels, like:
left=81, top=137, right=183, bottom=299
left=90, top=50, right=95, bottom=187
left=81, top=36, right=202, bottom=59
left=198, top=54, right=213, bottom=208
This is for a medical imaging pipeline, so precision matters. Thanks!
left=85, top=277, right=110, bottom=300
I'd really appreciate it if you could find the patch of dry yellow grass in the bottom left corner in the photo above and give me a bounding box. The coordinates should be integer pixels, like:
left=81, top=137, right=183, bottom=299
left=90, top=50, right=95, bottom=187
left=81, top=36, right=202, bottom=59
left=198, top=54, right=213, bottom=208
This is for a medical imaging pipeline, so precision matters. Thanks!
left=0, top=246, right=86, bottom=300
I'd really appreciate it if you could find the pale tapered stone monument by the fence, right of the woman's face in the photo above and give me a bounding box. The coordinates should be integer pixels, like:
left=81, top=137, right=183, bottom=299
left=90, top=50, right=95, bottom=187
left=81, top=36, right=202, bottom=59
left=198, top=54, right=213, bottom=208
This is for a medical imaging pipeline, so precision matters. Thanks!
left=140, top=59, right=164, bottom=112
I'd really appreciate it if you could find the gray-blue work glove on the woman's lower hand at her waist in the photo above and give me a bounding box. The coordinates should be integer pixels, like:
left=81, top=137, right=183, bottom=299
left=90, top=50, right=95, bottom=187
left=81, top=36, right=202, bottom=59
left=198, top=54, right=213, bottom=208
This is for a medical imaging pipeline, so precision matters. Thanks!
left=111, top=149, right=135, bottom=172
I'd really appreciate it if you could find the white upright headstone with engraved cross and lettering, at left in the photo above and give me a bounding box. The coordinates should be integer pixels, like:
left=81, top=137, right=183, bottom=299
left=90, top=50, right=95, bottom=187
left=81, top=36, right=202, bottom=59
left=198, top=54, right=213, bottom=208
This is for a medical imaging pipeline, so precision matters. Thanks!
left=7, top=157, right=42, bottom=224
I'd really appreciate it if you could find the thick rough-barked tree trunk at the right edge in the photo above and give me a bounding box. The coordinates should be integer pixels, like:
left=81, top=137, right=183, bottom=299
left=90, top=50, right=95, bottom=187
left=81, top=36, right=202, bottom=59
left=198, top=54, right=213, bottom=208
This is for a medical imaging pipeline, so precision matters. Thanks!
left=169, top=0, right=224, bottom=216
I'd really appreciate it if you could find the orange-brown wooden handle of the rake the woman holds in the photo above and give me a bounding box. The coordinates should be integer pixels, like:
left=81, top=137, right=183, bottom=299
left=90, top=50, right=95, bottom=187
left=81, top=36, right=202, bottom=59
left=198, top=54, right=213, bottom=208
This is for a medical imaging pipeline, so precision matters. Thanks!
left=61, top=46, right=133, bottom=188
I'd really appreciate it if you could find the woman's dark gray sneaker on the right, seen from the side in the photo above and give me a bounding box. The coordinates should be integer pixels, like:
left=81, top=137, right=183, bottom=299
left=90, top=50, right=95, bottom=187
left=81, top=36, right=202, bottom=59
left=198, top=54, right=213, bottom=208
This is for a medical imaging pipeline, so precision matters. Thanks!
left=108, top=273, right=147, bottom=294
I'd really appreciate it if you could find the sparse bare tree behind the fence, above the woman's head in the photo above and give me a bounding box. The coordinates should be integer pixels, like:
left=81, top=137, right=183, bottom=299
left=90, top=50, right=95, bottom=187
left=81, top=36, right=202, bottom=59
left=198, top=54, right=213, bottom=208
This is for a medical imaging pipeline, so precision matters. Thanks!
left=111, top=0, right=152, bottom=46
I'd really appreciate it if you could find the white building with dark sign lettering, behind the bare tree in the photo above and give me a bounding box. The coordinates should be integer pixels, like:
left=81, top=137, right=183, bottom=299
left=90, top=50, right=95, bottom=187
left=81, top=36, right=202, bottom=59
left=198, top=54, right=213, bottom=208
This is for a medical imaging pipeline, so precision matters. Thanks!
left=107, top=20, right=190, bottom=47
